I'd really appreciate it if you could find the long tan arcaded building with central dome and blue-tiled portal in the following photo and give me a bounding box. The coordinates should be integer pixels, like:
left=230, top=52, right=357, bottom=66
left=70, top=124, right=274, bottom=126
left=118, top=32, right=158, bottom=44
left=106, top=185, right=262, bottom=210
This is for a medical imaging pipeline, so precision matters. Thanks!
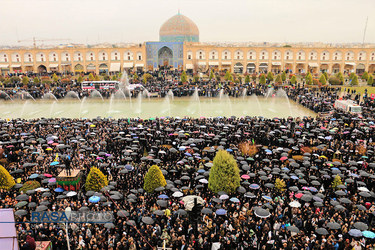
left=0, top=13, right=375, bottom=75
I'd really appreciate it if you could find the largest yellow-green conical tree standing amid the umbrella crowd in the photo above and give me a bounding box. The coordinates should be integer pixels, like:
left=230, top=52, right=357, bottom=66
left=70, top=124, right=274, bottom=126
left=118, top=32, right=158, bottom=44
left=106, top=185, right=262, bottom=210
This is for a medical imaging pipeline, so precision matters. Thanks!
left=208, top=150, right=240, bottom=194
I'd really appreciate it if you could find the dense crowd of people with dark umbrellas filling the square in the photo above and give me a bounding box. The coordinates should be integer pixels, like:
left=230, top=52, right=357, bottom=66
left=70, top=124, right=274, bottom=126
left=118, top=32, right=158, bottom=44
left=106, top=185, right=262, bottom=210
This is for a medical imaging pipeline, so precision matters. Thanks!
left=0, top=75, right=375, bottom=250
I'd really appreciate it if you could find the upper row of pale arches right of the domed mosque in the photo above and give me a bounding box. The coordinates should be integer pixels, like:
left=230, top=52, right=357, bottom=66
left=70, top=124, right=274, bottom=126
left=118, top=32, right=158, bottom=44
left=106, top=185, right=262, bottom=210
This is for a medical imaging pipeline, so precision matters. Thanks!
left=187, top=49, right=375, bottom=61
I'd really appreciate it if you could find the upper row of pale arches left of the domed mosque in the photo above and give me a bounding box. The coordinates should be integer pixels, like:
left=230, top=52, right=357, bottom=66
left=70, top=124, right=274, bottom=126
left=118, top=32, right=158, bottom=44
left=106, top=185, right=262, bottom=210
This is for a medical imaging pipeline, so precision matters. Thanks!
left=0, top=51, right=143, bottom=63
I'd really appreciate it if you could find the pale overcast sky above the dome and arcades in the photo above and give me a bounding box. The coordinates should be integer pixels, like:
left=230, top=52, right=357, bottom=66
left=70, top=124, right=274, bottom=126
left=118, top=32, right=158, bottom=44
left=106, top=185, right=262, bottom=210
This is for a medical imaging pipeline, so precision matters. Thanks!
left=0, top=0, right=375, bottom=45
